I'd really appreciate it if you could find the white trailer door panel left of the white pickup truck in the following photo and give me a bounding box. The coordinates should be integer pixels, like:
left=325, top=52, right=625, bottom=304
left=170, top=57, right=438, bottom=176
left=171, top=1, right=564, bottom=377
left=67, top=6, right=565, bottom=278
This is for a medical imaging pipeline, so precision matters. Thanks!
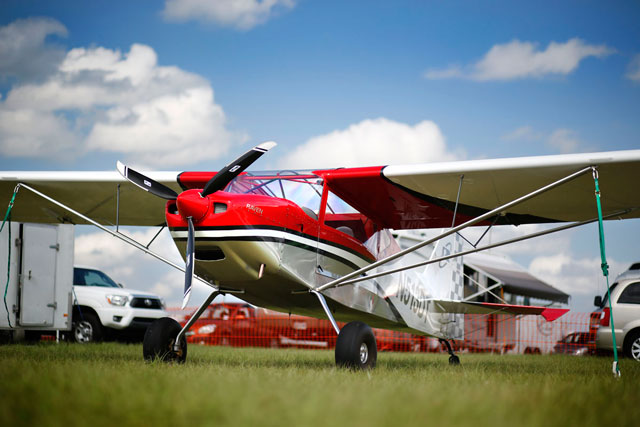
left=20, top=224, right=59, bottom=326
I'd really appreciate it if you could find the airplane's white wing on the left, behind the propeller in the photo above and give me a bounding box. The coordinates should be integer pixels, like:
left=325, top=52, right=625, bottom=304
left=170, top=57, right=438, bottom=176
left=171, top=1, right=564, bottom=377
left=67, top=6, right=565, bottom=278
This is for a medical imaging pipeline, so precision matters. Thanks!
left=0, top=171, right=181, bottom=225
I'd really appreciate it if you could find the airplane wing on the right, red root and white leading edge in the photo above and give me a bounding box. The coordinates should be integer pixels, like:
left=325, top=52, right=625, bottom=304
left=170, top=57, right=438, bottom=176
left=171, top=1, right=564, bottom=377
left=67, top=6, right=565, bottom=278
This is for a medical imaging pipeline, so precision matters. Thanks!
left=315, top=150, right=640, bottom=230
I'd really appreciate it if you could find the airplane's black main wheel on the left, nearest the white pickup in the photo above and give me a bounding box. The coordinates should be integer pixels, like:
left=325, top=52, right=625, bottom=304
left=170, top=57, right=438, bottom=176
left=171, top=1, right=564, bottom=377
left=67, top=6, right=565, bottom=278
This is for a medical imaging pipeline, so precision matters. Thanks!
left=142, top=317, right=187, bottom=363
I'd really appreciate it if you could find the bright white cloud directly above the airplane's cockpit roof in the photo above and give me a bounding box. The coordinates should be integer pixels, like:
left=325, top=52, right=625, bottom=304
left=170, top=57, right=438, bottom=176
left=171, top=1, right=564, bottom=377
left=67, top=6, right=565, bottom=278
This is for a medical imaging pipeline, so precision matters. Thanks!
left=280, top=118, right=461, bottom=169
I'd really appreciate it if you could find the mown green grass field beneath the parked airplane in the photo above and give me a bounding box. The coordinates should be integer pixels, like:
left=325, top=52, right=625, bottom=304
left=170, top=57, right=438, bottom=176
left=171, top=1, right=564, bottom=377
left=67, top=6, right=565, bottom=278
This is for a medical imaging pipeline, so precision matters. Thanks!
left=0, top=343, right=640, bottom=427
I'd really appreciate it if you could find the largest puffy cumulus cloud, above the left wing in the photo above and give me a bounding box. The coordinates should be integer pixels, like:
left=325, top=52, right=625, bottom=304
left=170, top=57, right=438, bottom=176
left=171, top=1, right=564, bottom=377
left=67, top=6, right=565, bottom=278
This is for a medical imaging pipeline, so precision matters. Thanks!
left=0, top=20, right=246, bottom=167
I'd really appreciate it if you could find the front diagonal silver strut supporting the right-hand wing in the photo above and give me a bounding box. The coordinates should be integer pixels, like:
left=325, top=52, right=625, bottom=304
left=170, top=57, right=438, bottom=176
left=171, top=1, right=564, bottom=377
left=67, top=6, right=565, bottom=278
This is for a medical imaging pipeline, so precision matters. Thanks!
left=315, top=166, right=591, bottom=292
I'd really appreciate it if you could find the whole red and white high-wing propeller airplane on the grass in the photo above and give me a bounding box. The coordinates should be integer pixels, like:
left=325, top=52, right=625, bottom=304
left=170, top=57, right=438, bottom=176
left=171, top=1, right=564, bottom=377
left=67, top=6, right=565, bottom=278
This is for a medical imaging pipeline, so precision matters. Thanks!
left=0, top=142, right=640, bottom=369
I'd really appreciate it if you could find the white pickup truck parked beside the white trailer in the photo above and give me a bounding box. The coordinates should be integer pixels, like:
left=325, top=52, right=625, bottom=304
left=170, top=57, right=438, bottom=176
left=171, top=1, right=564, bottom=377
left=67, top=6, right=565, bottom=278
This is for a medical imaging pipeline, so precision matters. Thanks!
left=70, top=267, right=167, bottom=343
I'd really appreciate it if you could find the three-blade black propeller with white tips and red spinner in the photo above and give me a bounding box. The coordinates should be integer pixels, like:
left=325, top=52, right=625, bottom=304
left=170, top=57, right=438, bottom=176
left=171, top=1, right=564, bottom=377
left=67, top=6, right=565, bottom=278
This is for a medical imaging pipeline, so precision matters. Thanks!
left=117, top=141, right=276, bottom=308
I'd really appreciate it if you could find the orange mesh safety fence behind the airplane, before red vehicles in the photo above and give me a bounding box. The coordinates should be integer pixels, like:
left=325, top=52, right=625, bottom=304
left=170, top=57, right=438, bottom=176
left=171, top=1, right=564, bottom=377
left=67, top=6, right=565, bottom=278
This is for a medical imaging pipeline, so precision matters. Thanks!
left=170, top=304, right=595, bottom=354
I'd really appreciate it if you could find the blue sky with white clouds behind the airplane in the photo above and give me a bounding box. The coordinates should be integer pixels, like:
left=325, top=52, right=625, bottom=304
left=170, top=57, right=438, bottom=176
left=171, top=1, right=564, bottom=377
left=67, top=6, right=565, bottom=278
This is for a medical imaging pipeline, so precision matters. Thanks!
left=0, top=0, right=640, bottom=311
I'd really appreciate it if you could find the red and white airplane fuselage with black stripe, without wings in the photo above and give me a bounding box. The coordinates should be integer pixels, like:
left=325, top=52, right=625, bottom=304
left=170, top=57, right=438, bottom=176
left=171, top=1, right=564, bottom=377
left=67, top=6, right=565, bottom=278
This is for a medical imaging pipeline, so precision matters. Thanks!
left=166, top=173, right=450, bottom=335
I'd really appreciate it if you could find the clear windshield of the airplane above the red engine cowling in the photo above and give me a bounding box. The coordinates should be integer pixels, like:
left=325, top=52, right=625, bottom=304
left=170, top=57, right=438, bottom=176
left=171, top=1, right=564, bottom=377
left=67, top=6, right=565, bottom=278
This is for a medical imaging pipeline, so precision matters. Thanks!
left=225, top=171, right=322, bottom=213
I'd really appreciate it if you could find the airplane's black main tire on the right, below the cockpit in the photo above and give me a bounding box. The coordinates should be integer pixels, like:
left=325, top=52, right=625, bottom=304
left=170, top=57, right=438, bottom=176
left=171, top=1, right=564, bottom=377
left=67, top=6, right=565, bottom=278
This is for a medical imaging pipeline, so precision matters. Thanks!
left=336, top=322, right=378, bottom=369
